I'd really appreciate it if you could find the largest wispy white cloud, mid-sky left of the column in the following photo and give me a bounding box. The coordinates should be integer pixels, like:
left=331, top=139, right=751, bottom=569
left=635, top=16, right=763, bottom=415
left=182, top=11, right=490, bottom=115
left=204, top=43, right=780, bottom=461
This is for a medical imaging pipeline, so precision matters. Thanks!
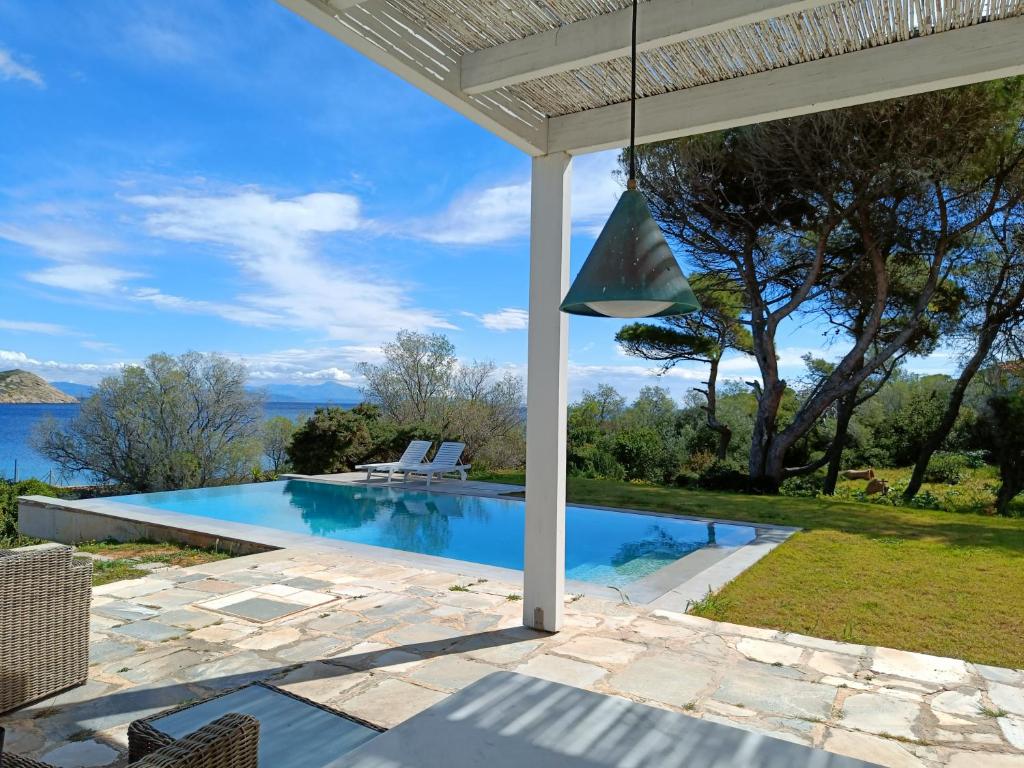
left=129, top=189, right=452, bottom=339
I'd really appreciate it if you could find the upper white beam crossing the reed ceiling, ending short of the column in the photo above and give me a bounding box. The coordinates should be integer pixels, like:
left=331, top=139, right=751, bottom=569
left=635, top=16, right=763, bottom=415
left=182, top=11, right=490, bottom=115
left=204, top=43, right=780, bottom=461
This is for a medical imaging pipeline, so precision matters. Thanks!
left=461, top=0, right=835, bottom=93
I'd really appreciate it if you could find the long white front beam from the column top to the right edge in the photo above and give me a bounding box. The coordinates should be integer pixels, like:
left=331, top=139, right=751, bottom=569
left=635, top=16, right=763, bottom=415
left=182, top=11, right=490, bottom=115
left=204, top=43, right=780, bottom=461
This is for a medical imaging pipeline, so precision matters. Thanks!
left=548, top=16, right=1024, bottom=154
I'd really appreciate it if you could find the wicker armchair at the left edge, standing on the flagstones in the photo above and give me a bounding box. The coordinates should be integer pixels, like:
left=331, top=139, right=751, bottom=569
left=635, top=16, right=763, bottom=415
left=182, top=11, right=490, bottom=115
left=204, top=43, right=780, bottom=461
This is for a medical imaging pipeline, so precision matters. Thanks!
left=0, top=544, right=92, bottom=716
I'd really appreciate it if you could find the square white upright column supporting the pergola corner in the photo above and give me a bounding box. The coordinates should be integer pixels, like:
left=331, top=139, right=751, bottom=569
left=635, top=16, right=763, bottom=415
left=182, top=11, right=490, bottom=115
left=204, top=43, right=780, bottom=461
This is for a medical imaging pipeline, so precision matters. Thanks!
left=522, top=153, right=572, bottom=632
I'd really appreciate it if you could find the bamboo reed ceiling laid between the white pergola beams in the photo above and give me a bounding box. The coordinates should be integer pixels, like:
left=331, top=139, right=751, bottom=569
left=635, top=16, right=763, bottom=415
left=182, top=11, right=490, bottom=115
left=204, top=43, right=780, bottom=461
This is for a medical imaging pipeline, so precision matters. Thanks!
left=338, top=0, right=1024, bottom=122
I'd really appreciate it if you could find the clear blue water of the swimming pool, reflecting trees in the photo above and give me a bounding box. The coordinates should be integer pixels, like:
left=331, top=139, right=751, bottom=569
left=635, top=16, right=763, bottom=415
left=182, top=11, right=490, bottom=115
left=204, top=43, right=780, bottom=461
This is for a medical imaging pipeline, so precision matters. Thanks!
left=108, top=480, right=755, bottom=587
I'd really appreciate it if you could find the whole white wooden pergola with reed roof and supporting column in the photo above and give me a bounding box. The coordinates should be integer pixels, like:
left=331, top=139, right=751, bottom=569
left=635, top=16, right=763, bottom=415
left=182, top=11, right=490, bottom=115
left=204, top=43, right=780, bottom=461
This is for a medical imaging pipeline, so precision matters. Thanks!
left=279, top=0, right=1024, bottom=631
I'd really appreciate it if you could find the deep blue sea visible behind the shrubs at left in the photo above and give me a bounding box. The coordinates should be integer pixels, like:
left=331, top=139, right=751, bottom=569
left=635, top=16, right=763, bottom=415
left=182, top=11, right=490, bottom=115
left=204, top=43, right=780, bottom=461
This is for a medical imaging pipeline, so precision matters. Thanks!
left=0, top=402, right=353, bottom=485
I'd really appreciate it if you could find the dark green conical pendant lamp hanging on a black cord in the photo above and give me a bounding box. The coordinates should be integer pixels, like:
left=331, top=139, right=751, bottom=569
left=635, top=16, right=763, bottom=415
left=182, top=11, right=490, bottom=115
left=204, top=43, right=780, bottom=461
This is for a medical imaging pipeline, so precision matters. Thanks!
left=561, top=0, right=700, bottom=317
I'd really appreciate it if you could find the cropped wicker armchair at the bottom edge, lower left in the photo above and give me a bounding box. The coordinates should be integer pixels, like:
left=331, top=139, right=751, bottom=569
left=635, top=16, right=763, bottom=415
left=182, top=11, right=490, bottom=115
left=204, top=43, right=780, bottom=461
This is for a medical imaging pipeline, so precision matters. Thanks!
left=0, top=714, right=259, bottom=768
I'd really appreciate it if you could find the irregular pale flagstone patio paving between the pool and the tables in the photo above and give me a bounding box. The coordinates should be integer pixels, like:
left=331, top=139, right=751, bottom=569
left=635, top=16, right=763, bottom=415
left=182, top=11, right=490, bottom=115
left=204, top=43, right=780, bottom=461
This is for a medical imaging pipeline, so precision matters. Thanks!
left=0, top=550, right=1024, bottom=768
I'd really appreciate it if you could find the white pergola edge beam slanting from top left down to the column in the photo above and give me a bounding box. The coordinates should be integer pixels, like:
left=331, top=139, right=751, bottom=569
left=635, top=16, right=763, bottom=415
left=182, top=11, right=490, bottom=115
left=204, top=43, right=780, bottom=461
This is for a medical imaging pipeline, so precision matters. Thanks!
left=278, top=0, right=546, bottom=156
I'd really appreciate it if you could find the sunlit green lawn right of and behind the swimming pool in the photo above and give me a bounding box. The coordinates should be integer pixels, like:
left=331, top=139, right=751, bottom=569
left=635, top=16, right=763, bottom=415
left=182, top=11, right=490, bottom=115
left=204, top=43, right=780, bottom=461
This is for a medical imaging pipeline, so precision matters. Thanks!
left=473, top=466, right=1024, bottom=668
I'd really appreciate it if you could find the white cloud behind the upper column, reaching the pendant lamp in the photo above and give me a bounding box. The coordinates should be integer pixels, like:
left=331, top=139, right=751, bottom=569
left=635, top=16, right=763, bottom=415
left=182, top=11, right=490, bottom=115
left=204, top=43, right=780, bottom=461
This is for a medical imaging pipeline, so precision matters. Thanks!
left=404, top=152, right=623, bottom=245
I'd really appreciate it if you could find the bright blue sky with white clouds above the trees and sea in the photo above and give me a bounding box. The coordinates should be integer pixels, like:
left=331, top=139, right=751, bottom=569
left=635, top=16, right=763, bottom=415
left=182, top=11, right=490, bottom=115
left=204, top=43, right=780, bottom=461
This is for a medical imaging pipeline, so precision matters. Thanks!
left=0, top=0, right=950, bottom=397
